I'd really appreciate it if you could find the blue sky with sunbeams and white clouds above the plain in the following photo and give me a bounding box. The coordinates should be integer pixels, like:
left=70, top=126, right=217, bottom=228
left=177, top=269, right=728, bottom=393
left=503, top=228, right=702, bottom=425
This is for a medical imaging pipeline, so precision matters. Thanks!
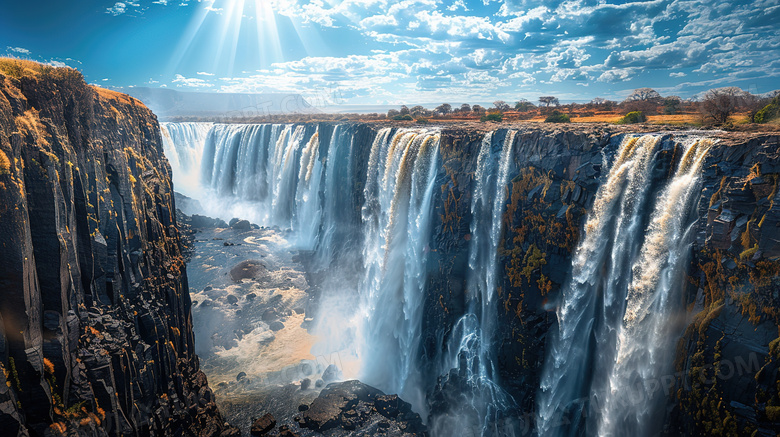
left=0, top=0, right=780, bottom=106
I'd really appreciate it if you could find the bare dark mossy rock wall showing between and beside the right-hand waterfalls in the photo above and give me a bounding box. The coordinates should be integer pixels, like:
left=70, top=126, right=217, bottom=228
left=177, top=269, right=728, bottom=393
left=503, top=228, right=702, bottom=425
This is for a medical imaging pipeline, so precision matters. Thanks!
left=422, top=125, right=780, bottom=436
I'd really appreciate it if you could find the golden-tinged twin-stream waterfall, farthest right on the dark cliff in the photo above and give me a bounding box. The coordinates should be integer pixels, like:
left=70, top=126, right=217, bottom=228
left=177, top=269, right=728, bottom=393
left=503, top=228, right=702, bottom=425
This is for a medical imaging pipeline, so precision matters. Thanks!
left=537, top=135, right=709, bottom=436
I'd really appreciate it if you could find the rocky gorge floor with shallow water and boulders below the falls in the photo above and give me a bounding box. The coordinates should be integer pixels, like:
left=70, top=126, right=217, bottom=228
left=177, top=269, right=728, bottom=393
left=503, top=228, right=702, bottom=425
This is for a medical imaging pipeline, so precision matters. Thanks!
left=177, top=196, right=426, bottom=436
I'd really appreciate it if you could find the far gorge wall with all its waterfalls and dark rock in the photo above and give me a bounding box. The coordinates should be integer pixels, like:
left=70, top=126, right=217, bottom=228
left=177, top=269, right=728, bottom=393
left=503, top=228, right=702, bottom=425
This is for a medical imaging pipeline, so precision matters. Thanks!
left=162, top=123, right=780, bottom=435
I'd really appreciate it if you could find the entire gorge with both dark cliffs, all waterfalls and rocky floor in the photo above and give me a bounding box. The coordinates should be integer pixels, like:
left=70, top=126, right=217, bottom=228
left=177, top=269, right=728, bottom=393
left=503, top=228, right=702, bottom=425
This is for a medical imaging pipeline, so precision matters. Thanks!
left=0, top=56, right=780, bottom=436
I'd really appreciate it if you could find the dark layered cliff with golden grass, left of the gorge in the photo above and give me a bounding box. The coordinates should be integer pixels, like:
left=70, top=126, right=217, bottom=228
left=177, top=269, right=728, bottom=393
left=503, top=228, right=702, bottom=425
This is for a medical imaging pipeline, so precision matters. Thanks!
left=0, top=63, right=233, bottom=436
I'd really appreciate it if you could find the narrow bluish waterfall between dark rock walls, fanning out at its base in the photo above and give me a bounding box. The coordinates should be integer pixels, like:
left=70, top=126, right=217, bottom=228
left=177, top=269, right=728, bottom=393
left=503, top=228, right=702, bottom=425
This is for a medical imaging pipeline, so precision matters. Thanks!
left=433, top=130, right=516, bottom=435
